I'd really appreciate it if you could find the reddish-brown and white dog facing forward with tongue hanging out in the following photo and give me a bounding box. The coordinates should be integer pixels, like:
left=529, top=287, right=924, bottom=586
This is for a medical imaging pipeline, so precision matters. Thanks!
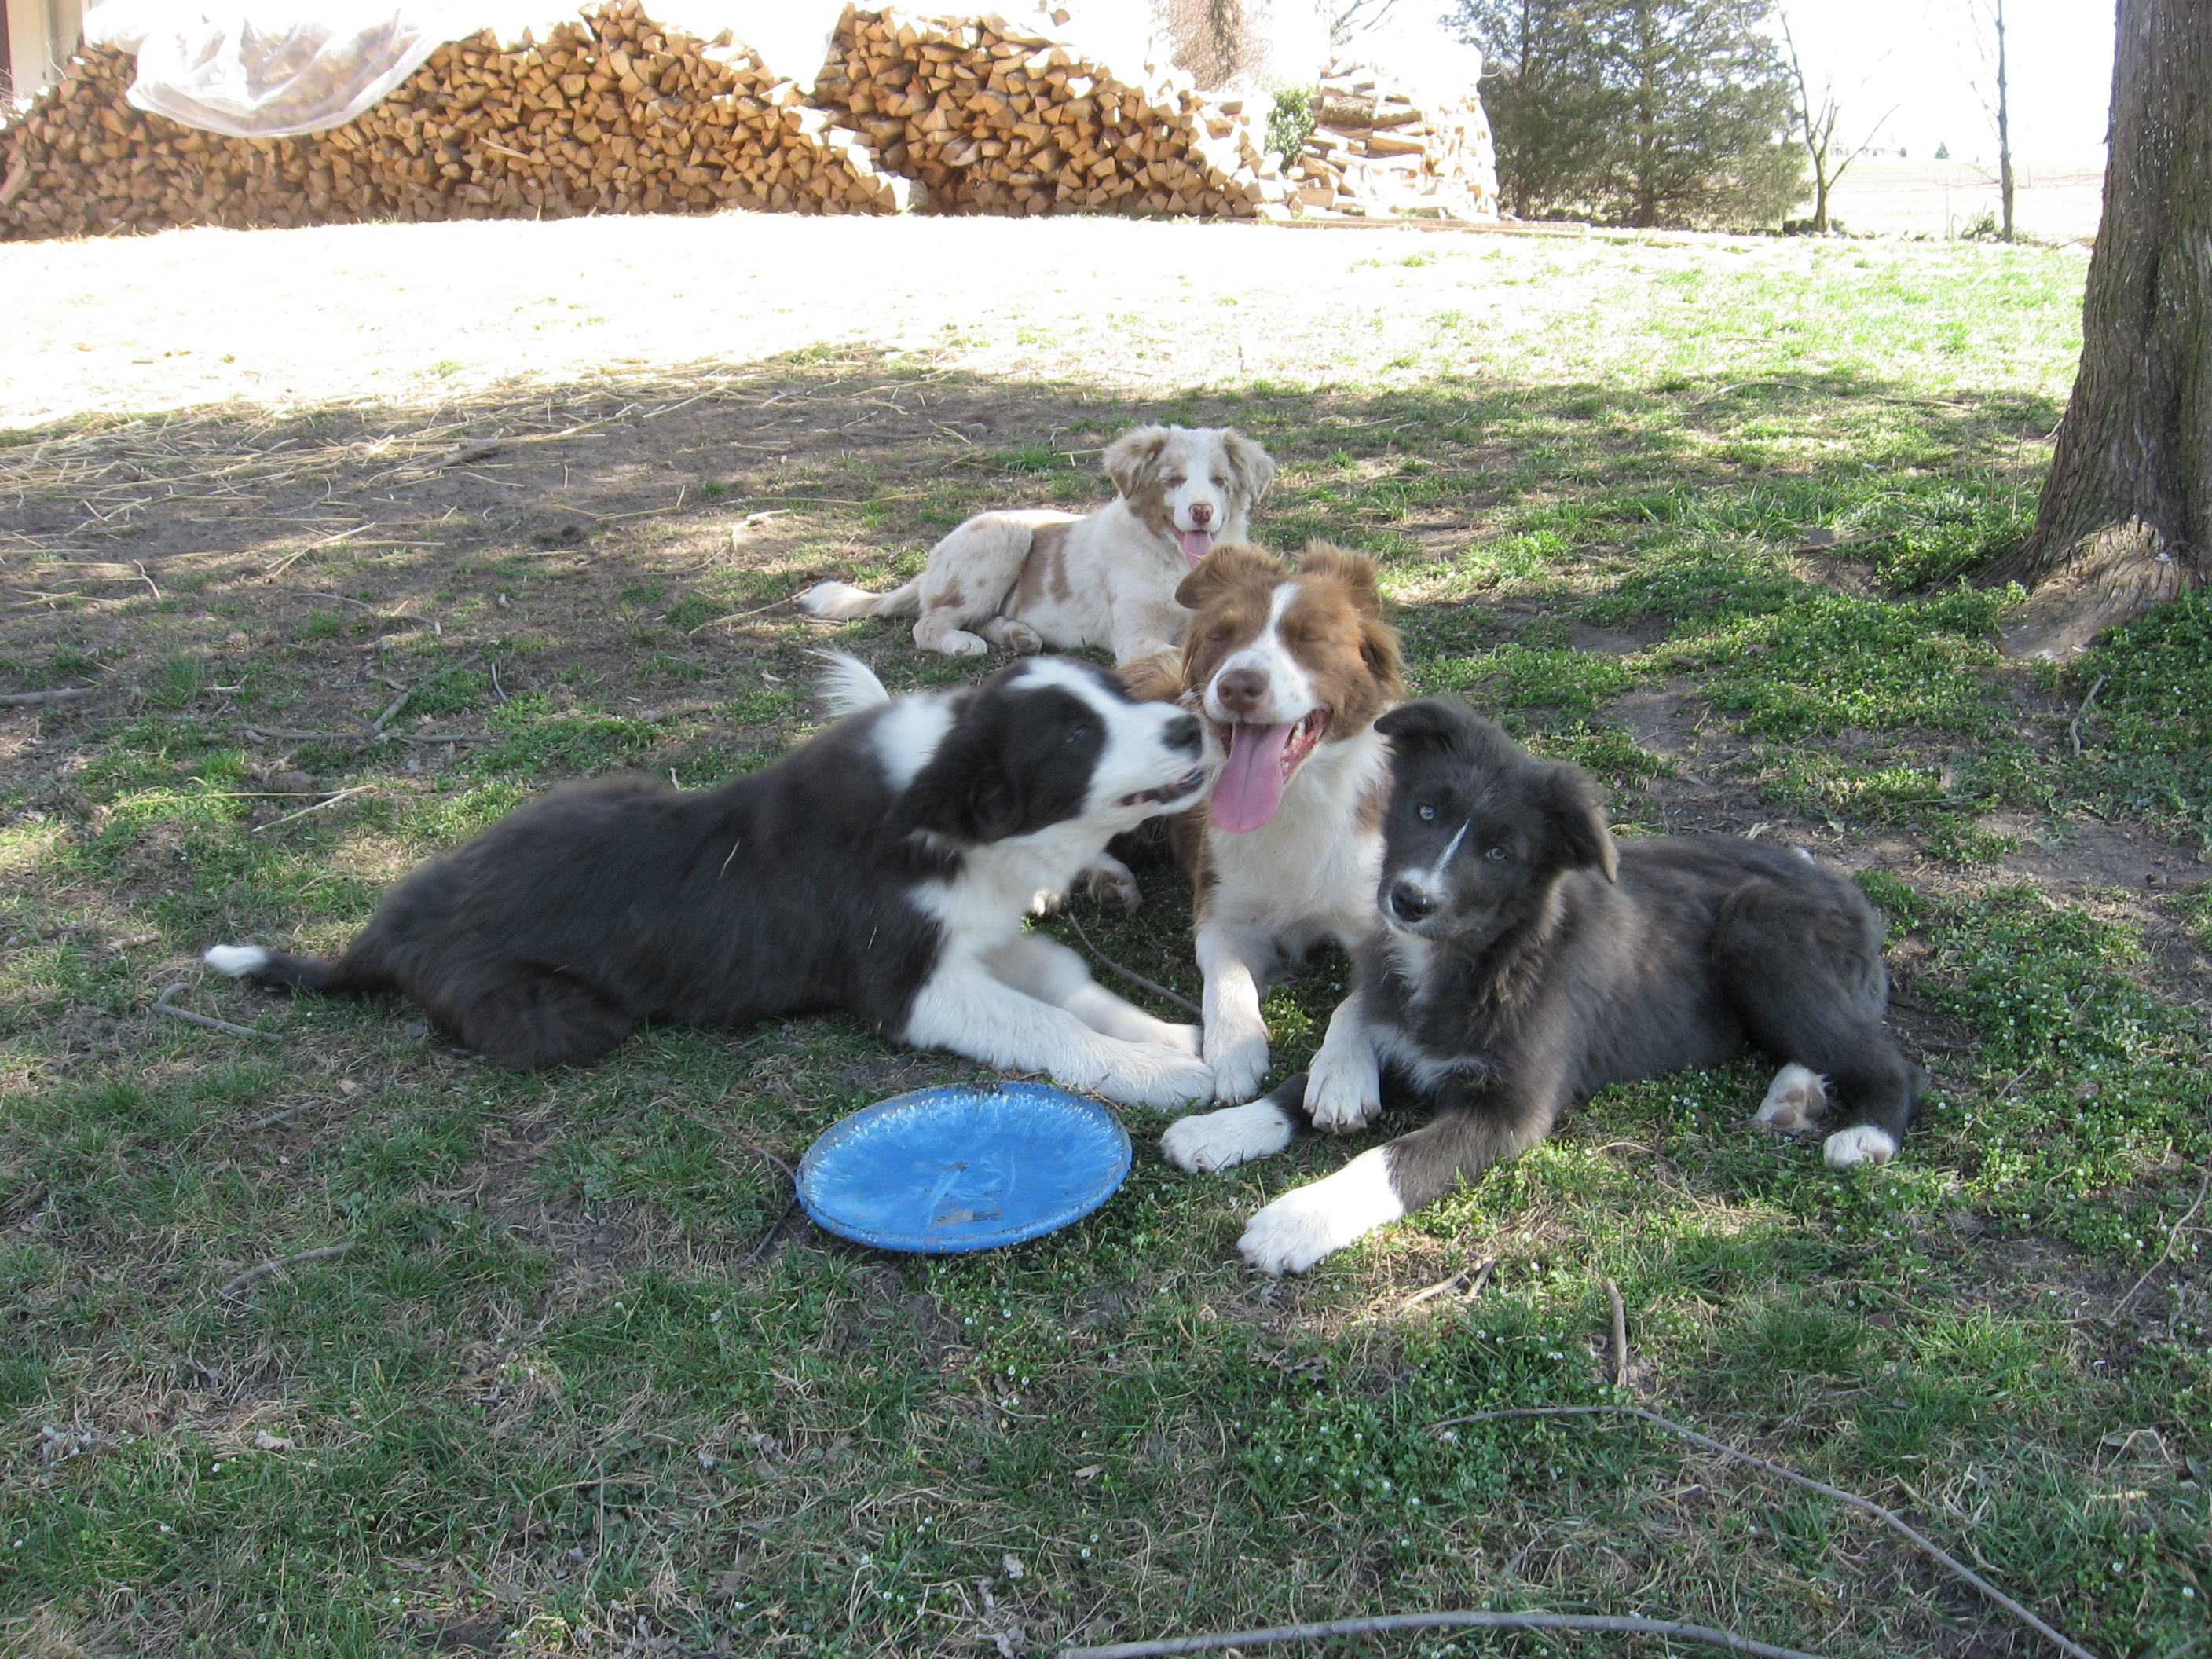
left=1163, top=542, right=1401, bottom=1119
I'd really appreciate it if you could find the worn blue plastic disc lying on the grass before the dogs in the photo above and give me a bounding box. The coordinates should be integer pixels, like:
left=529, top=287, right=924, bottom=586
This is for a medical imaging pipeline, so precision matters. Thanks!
left=799, top=1084, right=1128, bottom=1256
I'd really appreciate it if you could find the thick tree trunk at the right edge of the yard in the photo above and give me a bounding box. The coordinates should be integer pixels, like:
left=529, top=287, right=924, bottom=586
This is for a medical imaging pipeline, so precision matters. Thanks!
left=1990, top=0, right=2212, bottom=657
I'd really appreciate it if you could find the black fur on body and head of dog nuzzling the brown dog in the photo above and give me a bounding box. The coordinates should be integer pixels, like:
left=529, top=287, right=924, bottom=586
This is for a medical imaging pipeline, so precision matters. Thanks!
left=208, top=664, right=1201, bottom=1068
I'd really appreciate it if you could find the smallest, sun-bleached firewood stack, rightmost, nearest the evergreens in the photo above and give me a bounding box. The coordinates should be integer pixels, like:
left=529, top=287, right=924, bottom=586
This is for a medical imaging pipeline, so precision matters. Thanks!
left=1290, top=66, right=1497, bottom=219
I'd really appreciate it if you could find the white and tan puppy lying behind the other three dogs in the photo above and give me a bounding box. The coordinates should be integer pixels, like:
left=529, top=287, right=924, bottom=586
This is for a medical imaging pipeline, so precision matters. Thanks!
left=799, top=427, right=1274, bottom=668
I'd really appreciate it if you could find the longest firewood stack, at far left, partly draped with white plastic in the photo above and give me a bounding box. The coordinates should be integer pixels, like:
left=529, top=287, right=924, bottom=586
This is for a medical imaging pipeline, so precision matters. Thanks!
left=0, top=0, right=920, bottom=239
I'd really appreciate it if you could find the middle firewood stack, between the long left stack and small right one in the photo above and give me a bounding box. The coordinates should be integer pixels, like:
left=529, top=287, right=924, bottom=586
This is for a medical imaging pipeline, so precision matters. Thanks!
left=814, top=9, right=1287, bottom=219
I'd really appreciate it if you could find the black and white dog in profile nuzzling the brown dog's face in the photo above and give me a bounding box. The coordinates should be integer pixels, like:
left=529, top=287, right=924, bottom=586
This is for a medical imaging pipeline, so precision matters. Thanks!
left=206, top=657, right=1212, bottom=1106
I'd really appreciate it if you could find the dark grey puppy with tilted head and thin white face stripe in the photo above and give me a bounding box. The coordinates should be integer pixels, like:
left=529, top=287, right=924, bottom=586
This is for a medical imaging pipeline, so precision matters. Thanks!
left=1161, top=699, right=1922, bottom=1272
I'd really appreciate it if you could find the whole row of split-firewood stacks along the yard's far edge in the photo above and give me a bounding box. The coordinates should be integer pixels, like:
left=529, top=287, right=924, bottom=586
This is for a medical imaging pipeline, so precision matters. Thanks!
left=0, top=0, right=1496, bottom=239
